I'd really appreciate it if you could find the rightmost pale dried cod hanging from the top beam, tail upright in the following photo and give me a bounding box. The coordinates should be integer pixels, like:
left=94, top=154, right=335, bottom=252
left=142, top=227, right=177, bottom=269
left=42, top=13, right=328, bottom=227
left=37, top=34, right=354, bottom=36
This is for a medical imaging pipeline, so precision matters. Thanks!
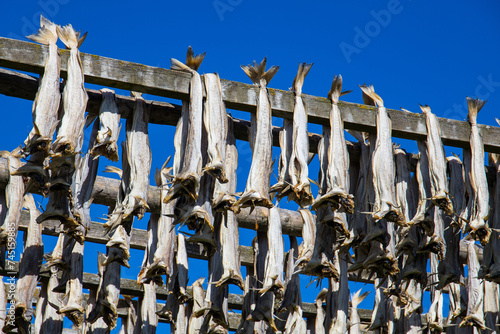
left=467, top=97, right=491, bottom=246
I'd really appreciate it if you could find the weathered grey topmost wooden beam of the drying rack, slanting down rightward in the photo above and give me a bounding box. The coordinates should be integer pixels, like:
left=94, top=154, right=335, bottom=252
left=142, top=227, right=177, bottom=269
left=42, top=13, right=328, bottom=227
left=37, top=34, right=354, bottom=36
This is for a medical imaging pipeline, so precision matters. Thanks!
left=0, top=37, right=500, bottom=153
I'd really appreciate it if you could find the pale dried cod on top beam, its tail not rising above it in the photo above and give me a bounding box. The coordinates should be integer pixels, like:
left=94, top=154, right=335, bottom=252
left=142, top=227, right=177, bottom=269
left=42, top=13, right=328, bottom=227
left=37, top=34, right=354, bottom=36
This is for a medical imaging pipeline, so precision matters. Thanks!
left=203, top=73, right=228, bottom=183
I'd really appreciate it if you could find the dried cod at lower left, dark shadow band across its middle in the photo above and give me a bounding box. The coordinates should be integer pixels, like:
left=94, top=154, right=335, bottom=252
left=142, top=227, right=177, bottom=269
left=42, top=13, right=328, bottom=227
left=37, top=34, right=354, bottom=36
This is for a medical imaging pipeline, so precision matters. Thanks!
left=12, top=194, right=43, bottom=332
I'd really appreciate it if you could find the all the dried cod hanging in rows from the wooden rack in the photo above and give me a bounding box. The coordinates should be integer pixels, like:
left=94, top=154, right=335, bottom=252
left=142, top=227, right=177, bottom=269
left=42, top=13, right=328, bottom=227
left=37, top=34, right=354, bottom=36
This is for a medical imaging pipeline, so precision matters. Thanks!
left=0, top=17, right=500, bottom=333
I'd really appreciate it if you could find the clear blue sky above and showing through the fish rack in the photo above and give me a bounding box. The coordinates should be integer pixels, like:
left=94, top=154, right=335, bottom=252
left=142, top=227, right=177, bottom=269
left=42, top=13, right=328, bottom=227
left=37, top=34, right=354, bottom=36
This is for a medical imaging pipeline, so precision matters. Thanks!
left=0, top=0, right=500, bottom=330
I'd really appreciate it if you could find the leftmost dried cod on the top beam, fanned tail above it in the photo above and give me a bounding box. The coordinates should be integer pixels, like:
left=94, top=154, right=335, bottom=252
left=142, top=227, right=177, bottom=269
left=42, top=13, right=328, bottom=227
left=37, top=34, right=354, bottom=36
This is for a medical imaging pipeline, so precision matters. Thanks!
left=23, top=15, right=61, bottom=157
